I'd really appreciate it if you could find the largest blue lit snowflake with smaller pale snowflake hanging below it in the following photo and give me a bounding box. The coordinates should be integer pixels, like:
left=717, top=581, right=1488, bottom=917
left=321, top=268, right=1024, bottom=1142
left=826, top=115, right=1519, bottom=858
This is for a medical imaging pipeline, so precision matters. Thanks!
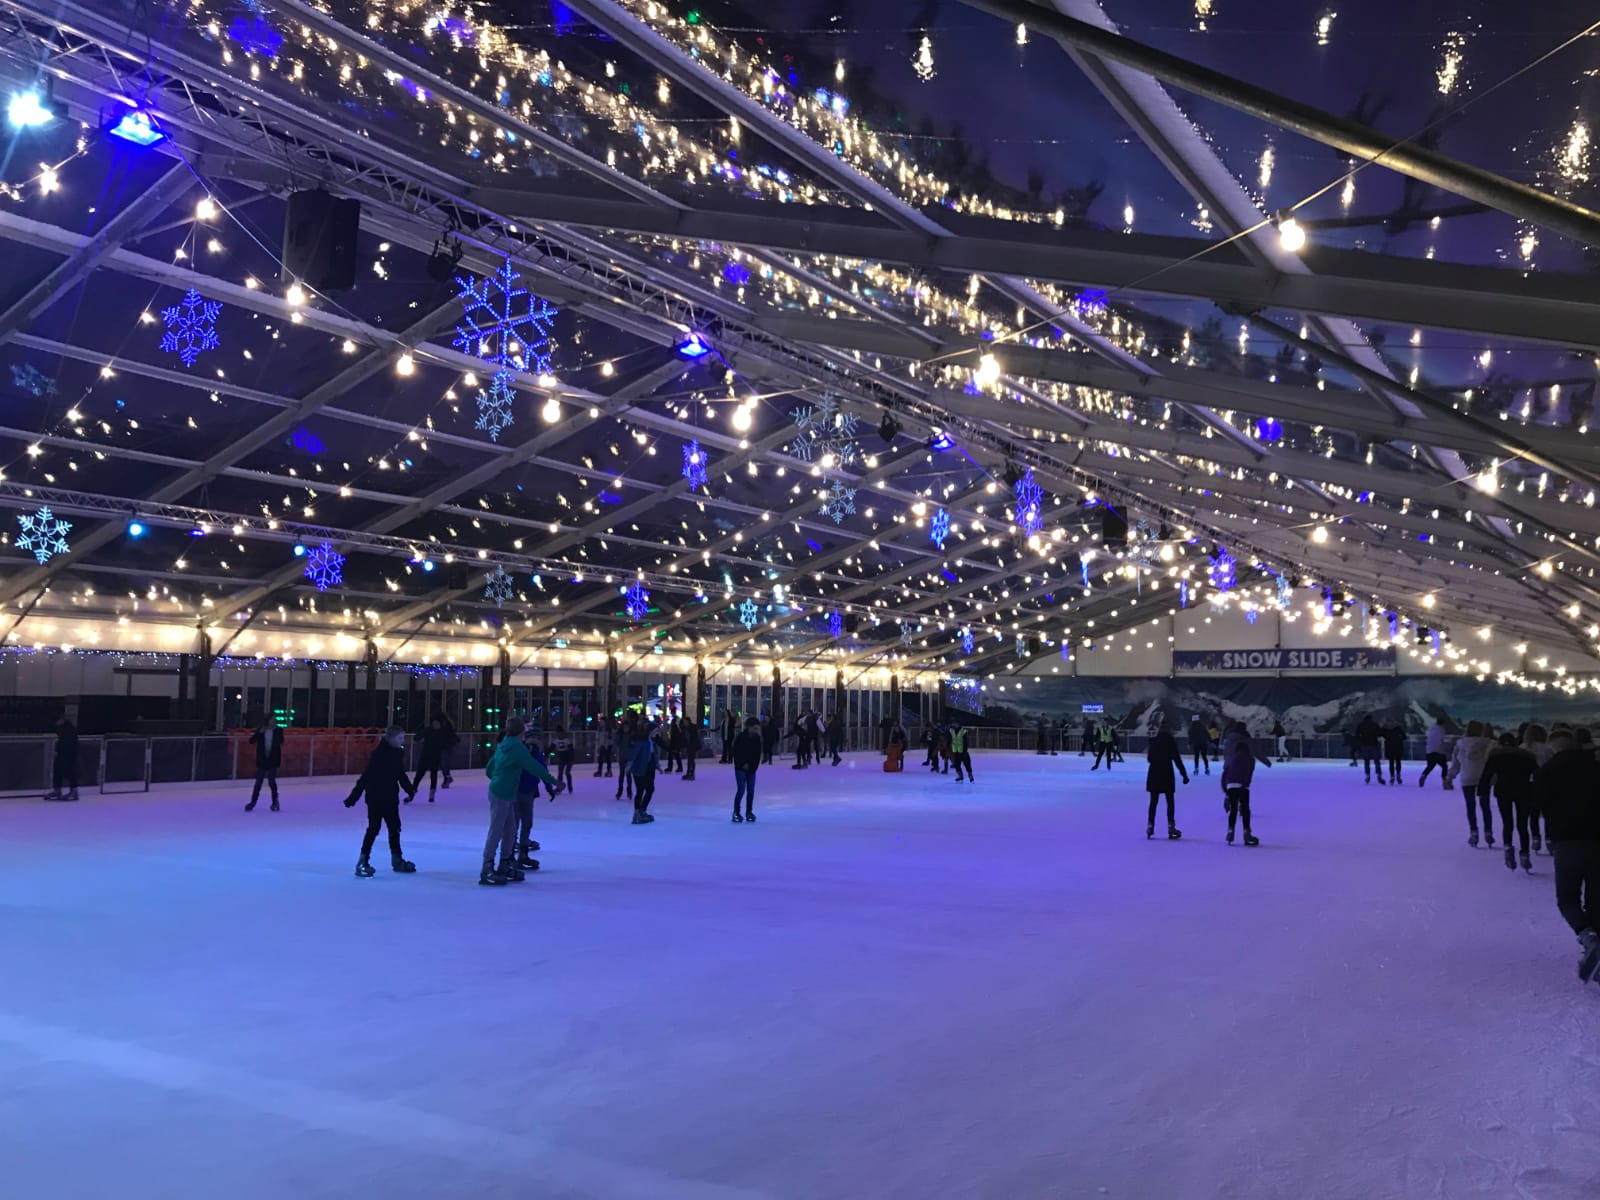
left=451, top=258, right=558, bottom=442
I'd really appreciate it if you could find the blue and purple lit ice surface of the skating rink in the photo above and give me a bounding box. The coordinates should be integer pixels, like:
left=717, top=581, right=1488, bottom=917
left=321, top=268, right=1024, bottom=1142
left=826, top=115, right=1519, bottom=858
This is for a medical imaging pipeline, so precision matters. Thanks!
left=0, top=754, right=1600, bottom=1200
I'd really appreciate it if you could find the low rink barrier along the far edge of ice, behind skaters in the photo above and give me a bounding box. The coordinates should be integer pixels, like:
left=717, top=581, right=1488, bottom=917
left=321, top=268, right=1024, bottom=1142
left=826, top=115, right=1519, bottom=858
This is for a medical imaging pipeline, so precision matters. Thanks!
left=0, top=726, right=1424, bottom=794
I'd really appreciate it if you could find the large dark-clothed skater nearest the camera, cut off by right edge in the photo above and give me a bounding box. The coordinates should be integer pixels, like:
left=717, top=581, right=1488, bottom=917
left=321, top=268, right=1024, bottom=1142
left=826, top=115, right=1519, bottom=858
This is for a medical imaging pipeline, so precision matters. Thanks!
left=1533, top=730, right=1600, bottom=982
